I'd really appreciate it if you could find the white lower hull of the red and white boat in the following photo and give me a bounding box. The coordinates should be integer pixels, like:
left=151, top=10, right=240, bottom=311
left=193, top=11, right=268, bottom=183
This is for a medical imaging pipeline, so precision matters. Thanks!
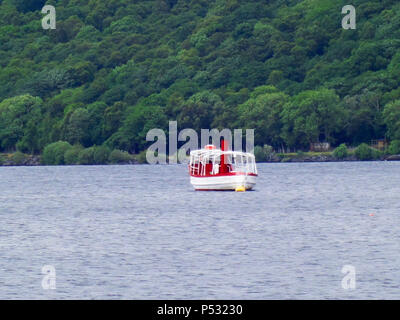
left=190, top=175, right=256, bottom=191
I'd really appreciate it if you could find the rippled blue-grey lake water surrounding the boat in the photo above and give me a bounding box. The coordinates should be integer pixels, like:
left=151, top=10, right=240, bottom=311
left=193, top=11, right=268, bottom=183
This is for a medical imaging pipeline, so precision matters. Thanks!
left=0, top=162, right=400, bottom=299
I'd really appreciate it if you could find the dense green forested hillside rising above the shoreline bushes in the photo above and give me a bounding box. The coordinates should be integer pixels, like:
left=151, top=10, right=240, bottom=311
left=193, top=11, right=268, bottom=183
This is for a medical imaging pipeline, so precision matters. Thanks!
left=0, top=0, right=400, bottom=159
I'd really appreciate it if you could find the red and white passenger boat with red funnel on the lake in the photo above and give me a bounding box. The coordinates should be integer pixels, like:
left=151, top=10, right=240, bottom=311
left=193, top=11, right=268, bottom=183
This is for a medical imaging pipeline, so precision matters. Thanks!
left=189, top=141, right=257, bottom=191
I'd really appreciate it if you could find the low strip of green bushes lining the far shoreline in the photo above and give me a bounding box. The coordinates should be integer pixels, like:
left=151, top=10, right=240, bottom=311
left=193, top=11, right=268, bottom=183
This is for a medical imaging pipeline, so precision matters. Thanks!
left=0, top=141, right=400, bottom=166
